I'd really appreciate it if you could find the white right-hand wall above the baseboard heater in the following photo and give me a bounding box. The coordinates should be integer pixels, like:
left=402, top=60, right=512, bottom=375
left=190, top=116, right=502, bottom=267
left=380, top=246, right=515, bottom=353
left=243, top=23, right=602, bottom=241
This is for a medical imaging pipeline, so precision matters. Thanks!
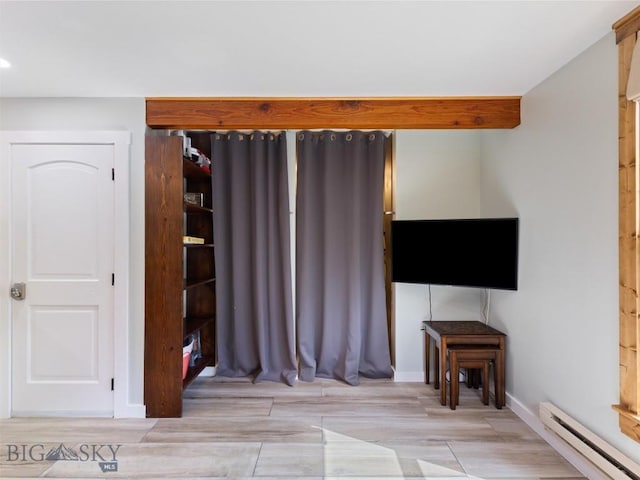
left=481, top=34, right=640, bottom=461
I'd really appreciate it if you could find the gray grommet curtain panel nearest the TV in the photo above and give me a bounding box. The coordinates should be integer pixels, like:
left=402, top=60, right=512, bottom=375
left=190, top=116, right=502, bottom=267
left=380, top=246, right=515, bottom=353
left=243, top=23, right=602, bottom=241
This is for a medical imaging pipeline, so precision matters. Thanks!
left=296, top=131, right=392, bottom=385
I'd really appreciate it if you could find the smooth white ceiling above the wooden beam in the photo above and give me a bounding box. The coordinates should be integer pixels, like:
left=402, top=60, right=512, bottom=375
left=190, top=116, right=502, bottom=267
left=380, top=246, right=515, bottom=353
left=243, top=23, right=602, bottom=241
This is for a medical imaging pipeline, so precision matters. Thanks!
left=0, top=0, right=640, bottom=97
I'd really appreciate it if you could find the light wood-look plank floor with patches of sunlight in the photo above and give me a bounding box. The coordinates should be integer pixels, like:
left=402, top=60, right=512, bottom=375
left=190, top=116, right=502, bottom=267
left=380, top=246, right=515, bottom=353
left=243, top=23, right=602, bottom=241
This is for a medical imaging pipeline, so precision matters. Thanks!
left=0, top=377, right=581, bottom=480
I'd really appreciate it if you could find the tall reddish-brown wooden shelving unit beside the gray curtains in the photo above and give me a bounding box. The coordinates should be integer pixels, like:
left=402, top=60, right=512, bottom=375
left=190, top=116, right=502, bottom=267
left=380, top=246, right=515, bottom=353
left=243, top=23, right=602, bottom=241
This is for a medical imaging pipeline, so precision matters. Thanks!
left=144, top=134, right=215, bottom=417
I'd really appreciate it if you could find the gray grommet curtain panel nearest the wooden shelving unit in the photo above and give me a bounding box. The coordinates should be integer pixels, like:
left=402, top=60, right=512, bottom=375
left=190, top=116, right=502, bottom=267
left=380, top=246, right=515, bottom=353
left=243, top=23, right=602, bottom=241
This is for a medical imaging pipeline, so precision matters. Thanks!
left=211, top=132, right=297, bottom=385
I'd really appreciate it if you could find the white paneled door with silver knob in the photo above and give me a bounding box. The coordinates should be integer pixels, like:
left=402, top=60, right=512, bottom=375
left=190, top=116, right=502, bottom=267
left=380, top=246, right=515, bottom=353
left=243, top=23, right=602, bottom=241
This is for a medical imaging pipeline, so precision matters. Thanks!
left=10, top=144, right=114, bottom=416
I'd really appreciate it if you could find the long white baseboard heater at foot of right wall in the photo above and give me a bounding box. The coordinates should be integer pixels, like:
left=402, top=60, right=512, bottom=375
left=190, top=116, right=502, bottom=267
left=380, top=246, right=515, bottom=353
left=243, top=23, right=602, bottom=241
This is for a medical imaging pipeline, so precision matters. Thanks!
left=540, top=402, right=640, bottom=480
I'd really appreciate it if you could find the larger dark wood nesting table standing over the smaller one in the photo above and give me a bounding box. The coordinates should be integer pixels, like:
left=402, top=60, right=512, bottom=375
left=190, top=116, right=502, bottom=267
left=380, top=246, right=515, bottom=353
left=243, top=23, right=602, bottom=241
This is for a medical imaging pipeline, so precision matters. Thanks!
left=422, top=320, right=506, bottom=408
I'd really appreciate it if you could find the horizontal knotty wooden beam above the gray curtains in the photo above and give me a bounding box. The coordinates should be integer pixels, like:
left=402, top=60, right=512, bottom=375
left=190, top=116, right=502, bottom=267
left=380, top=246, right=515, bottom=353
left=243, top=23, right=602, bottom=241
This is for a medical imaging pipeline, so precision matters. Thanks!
left=146, top=96, right=521, bottom=130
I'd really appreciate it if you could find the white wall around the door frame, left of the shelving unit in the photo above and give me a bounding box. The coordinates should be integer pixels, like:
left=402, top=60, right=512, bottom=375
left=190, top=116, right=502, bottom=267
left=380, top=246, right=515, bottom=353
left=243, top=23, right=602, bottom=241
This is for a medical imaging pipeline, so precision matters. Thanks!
left=0, top=98, right=146, bottom=405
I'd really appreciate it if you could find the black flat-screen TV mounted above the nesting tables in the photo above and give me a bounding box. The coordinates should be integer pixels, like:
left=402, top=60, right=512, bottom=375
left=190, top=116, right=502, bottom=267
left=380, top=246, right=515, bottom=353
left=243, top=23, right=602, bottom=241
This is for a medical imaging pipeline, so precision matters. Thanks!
left=391, top=218, right=518, bottom=290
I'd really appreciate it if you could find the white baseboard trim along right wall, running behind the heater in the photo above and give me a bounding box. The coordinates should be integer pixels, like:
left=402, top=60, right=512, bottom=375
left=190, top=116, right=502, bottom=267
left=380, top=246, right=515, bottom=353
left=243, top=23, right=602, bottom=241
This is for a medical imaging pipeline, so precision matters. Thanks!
left=507, top=393, right=610, bottom=480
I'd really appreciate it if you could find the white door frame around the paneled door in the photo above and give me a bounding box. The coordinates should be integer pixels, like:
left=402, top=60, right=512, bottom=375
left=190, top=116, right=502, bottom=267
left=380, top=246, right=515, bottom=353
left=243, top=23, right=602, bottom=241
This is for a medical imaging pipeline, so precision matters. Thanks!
left=0, top=131, right=135, bottom=418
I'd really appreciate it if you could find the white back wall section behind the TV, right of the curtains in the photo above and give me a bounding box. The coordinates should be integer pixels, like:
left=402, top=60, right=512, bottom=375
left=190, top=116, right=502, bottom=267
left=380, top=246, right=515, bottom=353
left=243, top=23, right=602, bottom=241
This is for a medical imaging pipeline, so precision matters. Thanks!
left=394, top=130, right=483, bottom=381
